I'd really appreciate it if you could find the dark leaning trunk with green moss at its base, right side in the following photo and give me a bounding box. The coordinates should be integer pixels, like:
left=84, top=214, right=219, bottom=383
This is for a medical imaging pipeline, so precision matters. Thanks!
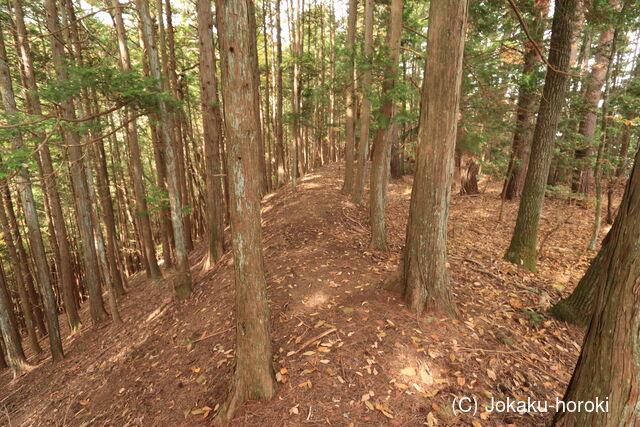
left=505, top=0, right=578, bottom=271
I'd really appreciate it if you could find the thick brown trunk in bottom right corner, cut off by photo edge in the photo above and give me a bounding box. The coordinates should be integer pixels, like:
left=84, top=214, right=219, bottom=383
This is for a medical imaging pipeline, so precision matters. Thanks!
left=553, top=144, right=640, bottom=427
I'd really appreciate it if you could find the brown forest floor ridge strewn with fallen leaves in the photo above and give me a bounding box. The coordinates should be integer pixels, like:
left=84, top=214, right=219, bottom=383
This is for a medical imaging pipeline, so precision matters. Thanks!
left=0, top=164, right=606, bottom=427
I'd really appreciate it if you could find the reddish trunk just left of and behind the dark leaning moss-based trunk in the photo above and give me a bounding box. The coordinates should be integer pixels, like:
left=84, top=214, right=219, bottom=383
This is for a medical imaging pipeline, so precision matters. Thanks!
left=502, top=1, right=549, bottom=200
